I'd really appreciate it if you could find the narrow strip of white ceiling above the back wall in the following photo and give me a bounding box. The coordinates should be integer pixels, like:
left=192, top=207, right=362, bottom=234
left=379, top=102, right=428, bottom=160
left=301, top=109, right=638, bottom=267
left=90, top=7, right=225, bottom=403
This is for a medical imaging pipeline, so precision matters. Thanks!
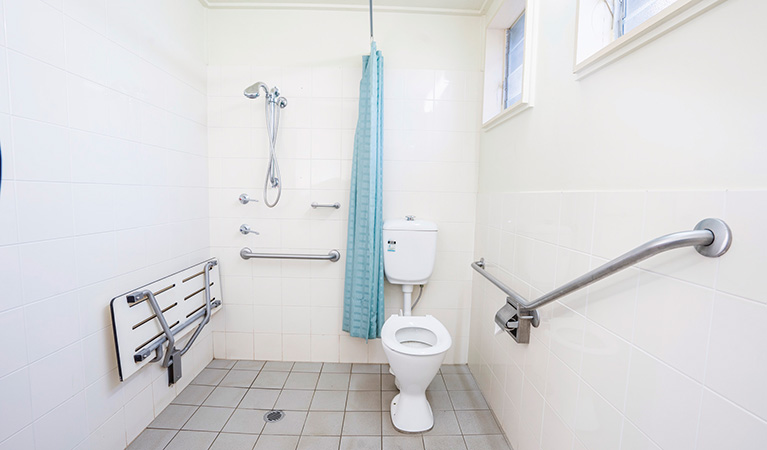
left=201, top=0, right=488, bottom=15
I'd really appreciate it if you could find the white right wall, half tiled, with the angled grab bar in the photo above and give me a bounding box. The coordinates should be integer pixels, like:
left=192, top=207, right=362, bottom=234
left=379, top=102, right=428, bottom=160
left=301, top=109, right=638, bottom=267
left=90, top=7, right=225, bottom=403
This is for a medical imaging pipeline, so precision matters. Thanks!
left=469, top=0, right=767, bottom=450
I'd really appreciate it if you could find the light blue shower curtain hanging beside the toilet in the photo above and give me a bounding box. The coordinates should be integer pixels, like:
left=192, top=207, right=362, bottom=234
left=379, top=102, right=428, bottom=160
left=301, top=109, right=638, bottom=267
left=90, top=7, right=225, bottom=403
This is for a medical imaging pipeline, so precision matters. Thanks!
left=343, top=41, right=385, bottom=340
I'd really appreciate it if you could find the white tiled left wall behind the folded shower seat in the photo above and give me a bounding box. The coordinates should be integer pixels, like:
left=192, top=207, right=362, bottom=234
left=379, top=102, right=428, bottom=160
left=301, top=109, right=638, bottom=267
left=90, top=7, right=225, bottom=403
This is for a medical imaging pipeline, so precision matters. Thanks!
left=0, top=0, right=212, bottom=450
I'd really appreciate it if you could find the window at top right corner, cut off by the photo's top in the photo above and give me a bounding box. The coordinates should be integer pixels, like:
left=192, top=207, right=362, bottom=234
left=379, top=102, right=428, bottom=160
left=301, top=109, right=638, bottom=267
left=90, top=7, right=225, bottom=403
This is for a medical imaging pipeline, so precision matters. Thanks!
left=574, top=0, right=725, bottom=78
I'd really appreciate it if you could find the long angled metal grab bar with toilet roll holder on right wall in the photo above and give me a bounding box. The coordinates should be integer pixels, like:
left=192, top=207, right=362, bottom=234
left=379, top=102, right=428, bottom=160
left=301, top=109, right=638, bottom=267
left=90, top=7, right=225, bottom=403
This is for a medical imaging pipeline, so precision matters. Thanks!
left=471, top=219, right=732, bottom=344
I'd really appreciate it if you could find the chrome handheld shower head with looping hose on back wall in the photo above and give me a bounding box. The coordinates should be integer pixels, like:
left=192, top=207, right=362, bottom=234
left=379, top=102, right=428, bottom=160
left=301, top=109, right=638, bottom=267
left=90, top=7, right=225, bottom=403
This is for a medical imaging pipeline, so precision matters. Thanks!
left=243, top=81, right=288, bottom=208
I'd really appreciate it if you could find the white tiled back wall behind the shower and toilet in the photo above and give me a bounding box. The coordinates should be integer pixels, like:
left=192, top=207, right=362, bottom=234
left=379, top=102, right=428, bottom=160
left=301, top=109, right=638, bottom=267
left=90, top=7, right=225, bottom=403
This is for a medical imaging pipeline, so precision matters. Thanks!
left=208, top=10, right=481, bottom=362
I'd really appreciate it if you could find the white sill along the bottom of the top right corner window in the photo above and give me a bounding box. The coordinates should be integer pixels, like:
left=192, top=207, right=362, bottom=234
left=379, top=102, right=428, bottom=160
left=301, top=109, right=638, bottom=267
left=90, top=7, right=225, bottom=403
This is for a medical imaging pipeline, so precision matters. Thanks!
left=573, top=0, right=725, bottom=80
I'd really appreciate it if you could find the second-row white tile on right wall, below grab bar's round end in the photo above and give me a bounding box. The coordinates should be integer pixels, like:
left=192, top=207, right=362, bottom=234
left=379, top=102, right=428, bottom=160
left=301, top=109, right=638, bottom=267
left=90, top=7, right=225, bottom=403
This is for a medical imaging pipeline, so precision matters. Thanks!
left=634, top=273, right=714, bottom=380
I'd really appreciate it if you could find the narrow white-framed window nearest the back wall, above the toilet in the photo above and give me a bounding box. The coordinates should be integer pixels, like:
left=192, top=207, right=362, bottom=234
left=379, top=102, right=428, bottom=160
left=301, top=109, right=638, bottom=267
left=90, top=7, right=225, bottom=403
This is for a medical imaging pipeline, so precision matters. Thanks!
left=482, top=0, right=536, bottom=129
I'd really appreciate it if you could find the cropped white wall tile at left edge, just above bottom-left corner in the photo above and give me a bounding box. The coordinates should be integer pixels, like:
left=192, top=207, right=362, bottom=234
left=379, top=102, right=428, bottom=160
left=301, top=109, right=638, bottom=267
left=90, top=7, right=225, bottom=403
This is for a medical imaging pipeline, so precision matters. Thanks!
left=0, top=368, right=32, bottom=440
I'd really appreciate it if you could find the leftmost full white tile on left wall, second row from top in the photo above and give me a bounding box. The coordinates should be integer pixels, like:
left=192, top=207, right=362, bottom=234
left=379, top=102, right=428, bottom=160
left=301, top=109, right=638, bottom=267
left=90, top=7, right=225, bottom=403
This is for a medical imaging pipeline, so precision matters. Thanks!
left=8, top=51, right=67, bottom=125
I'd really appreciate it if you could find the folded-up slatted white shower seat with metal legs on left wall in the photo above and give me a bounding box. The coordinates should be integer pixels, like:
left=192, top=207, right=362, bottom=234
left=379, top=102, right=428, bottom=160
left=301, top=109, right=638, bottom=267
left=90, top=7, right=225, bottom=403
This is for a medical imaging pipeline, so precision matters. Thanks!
left=110, top=259, right=222, bottom=385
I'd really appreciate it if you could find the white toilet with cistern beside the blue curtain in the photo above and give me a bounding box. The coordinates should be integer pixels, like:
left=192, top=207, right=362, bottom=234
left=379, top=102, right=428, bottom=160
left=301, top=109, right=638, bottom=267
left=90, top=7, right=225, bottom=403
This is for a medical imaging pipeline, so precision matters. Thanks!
left=381, top=216, right=453, bottom=433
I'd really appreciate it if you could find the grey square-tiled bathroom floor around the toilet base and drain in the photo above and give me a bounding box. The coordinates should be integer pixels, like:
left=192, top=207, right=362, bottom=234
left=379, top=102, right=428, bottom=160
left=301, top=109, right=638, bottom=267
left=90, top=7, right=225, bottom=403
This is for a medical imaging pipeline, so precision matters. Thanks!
left=128, top=360, right=509, bottom=450
